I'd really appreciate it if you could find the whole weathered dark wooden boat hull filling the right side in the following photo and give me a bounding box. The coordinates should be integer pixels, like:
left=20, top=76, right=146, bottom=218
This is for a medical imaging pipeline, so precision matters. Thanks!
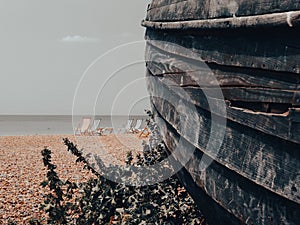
left=143, top=0, right=300, bottom=224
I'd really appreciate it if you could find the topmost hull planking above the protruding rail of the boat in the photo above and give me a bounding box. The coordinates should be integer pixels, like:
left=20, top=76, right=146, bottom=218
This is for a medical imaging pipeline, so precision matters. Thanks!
left=146, top=0, right=300, bottom=21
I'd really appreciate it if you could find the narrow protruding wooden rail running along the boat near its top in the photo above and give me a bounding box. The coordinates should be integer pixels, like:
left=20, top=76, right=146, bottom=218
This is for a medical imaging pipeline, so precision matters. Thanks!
left=142, top=10, right=300, bottom=30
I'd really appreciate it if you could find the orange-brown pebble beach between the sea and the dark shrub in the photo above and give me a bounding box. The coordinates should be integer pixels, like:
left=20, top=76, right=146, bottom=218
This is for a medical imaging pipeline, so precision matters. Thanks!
left=0, top=134, right=146, bottom=224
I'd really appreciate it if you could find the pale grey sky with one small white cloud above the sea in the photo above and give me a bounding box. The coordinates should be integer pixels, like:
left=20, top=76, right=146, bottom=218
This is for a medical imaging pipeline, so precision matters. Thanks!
left=0, top=0, right=149, bottom=114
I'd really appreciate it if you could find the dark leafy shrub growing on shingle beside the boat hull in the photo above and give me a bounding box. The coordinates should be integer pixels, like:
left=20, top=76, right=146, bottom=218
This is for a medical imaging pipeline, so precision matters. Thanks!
left=36, top=111, right=206, bottom=225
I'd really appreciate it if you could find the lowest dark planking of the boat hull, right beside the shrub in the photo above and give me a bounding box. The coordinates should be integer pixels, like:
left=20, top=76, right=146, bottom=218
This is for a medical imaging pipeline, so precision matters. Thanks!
left=153, top=107, right=300, bottom=225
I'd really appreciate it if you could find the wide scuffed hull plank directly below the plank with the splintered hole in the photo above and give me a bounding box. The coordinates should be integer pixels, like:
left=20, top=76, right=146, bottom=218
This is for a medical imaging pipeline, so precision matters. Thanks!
left=148, top=72, right=300, bottom=204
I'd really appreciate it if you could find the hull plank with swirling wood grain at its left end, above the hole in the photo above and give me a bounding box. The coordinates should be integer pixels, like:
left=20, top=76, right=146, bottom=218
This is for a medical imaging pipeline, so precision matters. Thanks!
left=145, top=44, right=300, bottom=90
